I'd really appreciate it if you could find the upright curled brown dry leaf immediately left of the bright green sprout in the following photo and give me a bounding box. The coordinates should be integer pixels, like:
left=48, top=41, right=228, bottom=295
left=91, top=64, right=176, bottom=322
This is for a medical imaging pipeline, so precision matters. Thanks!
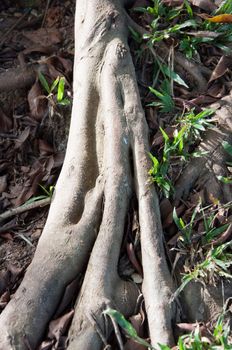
left=27, top=81, right=47, bottom=121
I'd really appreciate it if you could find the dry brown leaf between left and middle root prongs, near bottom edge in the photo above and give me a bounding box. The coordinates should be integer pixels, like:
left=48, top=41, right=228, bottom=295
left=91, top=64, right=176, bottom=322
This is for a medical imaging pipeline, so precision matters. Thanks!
left=48, top=310, right=74, bottom=343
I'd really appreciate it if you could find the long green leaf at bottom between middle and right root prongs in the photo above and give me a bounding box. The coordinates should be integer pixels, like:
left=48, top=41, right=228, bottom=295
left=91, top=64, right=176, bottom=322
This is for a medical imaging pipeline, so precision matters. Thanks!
left=103, top=308, right=155, bottom=350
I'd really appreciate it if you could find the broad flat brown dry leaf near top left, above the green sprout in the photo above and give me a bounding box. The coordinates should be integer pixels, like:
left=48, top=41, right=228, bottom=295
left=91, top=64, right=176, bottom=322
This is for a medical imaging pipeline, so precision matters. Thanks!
left=23, top=28, right=62, bottom=47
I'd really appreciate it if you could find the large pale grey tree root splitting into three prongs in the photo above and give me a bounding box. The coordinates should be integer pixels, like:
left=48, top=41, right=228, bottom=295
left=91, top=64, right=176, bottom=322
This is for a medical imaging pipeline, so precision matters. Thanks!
left=0, top=0, right=173, bottom=350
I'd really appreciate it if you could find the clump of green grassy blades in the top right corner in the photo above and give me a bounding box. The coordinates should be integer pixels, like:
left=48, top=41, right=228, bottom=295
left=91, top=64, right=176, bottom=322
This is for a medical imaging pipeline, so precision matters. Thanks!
left=134, top=0, right=232, bottom=58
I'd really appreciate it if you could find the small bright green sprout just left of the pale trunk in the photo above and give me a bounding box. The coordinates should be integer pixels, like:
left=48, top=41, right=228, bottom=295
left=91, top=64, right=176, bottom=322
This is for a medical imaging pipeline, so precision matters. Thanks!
left=38, top=72, right=70, bottom=106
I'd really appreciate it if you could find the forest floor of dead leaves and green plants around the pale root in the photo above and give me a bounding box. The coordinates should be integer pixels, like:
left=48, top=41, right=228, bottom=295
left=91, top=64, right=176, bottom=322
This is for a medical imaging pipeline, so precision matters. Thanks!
left=0, top=0, right=232, bottom=350
